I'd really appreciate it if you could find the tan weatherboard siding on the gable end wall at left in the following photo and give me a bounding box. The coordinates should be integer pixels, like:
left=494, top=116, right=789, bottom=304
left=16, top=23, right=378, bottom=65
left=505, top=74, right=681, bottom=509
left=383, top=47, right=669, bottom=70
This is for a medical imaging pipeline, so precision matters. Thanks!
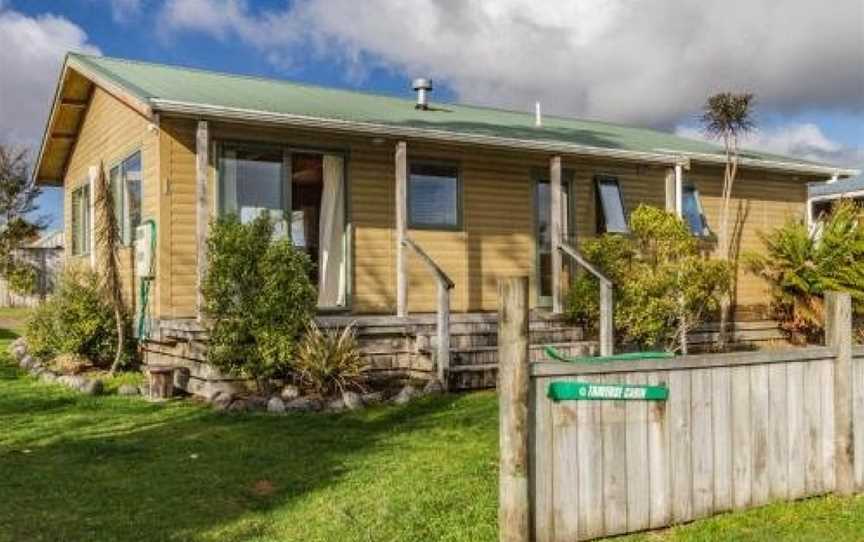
left=63, top=87, right=158, bottom=312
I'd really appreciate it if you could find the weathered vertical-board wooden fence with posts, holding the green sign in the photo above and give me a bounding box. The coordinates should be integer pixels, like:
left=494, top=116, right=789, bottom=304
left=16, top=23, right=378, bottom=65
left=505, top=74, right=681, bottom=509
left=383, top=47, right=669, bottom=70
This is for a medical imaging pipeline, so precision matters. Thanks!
left=499, top=281, right=864, bottom=541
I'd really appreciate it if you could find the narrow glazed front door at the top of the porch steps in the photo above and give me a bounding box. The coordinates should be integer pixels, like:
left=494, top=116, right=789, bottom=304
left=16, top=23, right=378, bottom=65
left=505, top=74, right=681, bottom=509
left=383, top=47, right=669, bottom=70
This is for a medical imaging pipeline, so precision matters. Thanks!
left=534, top=176, right=570, bottom=307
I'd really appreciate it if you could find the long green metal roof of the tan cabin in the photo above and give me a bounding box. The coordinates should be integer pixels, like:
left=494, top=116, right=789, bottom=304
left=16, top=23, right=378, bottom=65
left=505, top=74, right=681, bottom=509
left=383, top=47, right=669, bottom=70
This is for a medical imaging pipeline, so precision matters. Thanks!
left=32, top=53, right=857, bottom=185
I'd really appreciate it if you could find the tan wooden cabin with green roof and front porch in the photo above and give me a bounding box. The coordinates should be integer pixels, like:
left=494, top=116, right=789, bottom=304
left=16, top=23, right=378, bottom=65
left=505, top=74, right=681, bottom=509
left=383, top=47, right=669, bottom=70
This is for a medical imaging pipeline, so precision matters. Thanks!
left=35, top=54, right=856, bottom=396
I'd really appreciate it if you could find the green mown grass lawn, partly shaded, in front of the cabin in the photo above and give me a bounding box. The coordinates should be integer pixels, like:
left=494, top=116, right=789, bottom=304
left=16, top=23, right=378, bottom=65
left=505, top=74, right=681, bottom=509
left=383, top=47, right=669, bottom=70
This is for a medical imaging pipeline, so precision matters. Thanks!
left=0, top=313, right=864, bottom=542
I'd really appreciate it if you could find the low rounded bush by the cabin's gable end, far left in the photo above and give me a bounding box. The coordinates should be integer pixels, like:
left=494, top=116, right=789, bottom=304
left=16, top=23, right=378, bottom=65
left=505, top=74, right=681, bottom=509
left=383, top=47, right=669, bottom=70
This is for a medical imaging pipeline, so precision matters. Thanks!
left=25, top=267, right=117, bottom=365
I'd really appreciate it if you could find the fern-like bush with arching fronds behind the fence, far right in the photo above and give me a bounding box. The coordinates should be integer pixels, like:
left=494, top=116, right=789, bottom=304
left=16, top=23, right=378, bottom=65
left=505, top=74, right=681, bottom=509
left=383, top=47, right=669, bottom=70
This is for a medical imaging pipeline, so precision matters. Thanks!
left=744, top=201, right=864, bottom=340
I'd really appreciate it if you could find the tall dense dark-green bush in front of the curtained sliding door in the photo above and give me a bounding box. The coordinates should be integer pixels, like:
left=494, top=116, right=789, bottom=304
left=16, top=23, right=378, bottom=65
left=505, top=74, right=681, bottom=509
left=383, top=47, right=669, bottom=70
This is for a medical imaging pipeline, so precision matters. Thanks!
left=202, top=215, right=317, bottom=387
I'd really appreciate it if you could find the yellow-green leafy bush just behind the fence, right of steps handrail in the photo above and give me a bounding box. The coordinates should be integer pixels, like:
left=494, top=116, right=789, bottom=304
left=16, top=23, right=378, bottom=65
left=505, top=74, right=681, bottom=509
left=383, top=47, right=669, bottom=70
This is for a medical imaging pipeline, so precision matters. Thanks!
left=566, top=205, right=730, bottom=350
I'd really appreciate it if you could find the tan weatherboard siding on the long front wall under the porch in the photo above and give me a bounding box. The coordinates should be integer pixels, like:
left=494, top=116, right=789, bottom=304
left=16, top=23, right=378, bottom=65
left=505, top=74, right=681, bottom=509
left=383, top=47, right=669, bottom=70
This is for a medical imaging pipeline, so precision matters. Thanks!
left=160, top=119, right=806, bottom=317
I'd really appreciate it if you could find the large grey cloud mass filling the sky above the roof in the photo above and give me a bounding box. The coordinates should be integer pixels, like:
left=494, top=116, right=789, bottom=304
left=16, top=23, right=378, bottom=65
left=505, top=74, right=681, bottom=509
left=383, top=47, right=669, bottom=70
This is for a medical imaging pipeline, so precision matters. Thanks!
left=163, top=0, right=864, bottom=128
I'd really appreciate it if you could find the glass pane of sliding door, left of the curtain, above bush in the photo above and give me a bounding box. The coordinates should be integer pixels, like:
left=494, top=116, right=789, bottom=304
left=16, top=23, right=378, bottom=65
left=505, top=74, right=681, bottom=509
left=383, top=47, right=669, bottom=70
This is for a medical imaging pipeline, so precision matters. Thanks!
left=220, top=148, right=285, bottom=223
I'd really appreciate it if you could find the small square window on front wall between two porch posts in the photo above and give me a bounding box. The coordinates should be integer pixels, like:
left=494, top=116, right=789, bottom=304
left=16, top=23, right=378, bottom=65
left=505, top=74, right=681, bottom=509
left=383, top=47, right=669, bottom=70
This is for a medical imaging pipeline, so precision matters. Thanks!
left=408, top=163, right=462, bottom=230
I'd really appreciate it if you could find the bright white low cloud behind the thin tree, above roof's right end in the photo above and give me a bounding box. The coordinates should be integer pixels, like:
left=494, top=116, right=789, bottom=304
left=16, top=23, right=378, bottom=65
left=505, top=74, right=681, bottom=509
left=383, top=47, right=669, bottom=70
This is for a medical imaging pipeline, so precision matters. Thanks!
left=675, top=122, right=864, bottom=168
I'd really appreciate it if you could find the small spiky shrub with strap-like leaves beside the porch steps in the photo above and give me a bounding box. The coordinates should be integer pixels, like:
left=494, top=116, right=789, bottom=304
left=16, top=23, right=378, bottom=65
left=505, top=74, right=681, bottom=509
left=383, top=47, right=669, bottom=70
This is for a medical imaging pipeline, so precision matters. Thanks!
left=294, top=322, right=364, bottom=395
